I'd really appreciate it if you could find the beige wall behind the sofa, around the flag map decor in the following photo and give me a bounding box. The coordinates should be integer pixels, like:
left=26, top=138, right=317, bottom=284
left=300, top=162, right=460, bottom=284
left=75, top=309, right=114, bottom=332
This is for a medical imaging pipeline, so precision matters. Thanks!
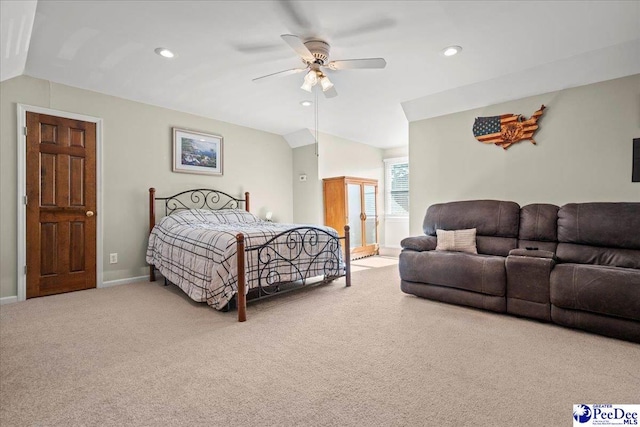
left=409, top=75, right=640, bottom=234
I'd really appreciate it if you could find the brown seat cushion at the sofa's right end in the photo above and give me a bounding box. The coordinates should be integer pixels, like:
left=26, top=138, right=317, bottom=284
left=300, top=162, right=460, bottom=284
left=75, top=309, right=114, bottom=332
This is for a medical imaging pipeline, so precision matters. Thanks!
left=550, top=264, right=640, bottom=321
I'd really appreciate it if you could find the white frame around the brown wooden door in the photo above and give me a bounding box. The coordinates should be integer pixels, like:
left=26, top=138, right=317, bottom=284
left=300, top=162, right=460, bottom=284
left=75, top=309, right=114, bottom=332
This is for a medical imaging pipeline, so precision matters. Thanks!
left=17, top=104, right=103, bottom=301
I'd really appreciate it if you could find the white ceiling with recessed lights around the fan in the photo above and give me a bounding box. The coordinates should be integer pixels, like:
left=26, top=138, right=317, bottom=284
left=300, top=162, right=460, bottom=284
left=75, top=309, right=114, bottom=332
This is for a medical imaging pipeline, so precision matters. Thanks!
left=1, top=0, right=640, bottom=148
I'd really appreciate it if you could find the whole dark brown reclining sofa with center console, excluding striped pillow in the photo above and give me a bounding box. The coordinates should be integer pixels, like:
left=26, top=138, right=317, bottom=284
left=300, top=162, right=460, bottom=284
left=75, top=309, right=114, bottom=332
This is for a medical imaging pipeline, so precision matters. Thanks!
left=399, top=200, right=640, bottom=343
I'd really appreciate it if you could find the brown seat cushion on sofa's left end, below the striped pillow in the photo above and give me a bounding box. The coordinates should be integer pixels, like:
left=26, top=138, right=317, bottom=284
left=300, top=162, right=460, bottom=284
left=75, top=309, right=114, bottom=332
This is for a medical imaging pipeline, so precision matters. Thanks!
left=399, top=251, right=507, bottom=296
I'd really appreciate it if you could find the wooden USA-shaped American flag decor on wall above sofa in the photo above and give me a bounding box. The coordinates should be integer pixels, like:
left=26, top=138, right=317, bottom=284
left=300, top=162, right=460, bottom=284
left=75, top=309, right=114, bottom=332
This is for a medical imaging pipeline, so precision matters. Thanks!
left=473, top=105, right=545, bottom=150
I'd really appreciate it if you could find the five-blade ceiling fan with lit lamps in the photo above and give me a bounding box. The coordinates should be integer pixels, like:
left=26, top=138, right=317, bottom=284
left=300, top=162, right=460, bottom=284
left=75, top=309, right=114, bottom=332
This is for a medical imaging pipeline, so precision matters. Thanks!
left=253, top=34, right=387, bottom=98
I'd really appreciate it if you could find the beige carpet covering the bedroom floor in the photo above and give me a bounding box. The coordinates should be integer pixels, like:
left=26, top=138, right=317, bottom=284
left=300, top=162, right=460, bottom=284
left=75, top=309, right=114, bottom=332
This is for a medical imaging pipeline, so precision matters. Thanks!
left=0, top=266, right=640, bottom=427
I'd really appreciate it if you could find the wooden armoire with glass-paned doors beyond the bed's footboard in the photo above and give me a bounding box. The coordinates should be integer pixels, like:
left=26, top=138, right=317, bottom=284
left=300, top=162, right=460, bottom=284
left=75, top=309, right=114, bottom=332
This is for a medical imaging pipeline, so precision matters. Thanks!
left=322, top=176, right=378, bottom=259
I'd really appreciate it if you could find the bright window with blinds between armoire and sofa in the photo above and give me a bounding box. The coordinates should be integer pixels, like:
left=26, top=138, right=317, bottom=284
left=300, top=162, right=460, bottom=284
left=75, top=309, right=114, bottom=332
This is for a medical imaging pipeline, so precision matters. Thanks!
left=384, top=157, right=409, bottom=216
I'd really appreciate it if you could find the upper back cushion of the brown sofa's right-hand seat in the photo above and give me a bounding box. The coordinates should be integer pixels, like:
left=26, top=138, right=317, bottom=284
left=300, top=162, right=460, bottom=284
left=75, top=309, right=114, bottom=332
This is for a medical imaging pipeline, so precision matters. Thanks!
left=558, top=203, right=640, bottom=249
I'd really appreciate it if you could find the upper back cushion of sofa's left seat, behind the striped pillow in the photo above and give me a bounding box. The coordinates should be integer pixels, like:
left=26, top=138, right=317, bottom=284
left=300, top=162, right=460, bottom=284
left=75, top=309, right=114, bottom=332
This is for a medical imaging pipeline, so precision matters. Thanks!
left=422, top=200, right=520, bottom=238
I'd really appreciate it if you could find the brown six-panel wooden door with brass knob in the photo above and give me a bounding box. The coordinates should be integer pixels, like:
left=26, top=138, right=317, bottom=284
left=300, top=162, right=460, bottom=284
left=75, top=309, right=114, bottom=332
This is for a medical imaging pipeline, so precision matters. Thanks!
left=25, top=112, right=97, bottom=298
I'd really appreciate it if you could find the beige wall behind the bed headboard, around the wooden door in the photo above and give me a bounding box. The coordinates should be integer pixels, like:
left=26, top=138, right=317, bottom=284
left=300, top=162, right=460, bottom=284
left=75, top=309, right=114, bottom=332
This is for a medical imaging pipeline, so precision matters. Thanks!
left=0, top=76, right=293, bottom=297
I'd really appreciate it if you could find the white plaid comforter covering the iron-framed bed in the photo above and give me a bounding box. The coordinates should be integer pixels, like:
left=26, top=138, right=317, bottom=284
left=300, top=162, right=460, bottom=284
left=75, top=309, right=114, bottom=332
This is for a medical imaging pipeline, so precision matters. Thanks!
left=146, top=209, right=344, bottom=310
